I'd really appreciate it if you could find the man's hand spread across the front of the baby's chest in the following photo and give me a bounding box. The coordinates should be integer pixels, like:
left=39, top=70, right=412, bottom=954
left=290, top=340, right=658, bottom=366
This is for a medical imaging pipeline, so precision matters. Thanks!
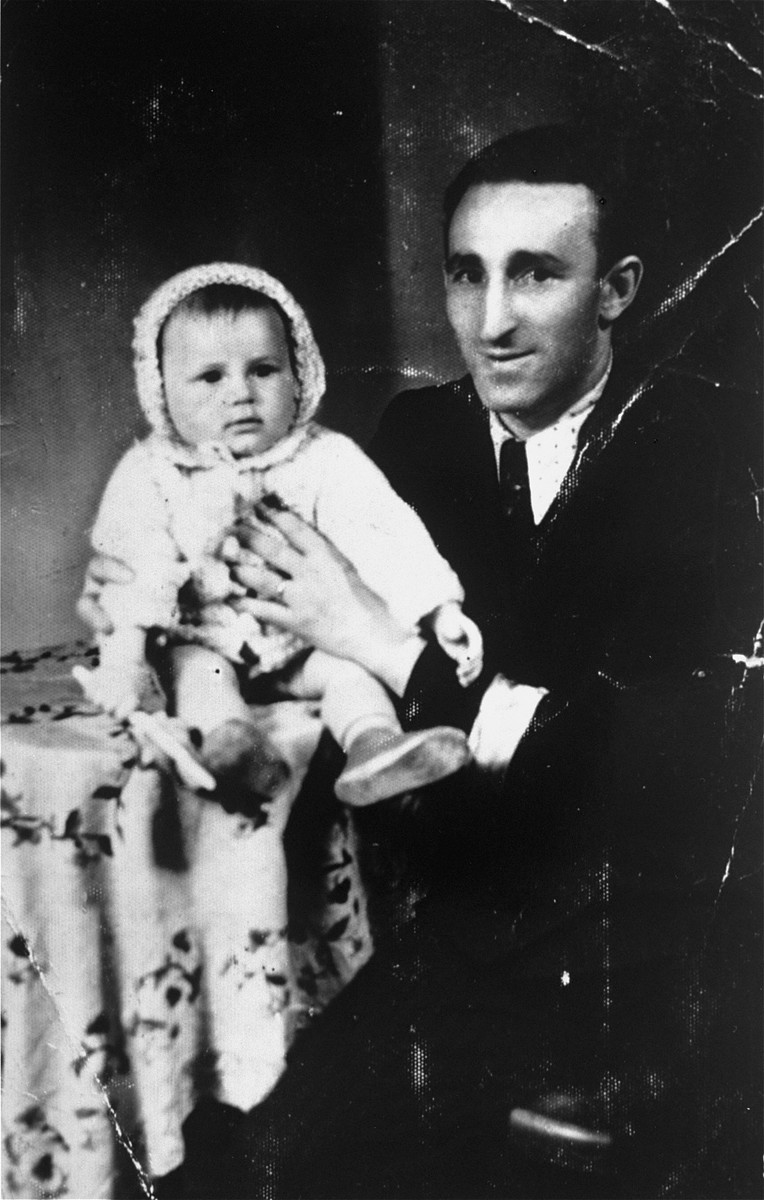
left=227, top=500, right=423, bottom=694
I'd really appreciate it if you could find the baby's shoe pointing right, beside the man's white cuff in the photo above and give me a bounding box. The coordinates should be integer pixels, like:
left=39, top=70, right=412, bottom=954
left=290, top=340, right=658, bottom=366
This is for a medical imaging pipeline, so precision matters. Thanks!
left=335, top=726, right=470, bottom=806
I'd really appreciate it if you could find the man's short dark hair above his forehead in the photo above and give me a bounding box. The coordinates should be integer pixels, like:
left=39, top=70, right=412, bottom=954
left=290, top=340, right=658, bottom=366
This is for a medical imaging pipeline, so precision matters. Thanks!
left=443, top=125, right=639, bottom=272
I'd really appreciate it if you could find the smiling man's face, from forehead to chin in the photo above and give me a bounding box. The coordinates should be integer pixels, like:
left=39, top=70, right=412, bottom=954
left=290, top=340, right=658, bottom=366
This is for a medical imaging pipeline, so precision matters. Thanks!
left=445, top=182, right=610, bottom=428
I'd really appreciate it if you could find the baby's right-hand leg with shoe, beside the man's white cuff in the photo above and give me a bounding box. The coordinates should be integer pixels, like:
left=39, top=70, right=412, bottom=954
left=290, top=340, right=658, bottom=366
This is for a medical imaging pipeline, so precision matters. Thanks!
left=302, top=650, right=470, bottom=805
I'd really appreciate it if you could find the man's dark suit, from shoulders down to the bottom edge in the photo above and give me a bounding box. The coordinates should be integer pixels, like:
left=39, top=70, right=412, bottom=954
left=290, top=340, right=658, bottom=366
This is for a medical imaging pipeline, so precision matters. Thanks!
left=186, top=362, right=760, bottom=1200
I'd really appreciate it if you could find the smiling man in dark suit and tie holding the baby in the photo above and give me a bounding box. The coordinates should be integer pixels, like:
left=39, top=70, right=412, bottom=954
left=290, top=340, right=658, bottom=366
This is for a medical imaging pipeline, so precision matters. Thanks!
left=80, top=128, right=758, bottom=1198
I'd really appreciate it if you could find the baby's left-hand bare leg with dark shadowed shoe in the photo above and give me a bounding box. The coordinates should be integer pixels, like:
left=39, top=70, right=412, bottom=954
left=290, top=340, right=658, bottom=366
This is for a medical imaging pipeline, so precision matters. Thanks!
left=172, top=646, right=289, bottom=811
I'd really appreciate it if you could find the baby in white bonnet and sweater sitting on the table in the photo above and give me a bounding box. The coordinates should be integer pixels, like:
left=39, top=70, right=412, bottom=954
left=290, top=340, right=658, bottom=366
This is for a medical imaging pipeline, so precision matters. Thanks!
left=80, top=263, right=482, bottom=805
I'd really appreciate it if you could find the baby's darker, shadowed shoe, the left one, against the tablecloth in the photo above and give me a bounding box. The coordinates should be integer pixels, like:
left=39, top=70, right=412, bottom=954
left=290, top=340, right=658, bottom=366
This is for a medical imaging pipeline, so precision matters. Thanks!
left=199, top=719, right=290, bottom=816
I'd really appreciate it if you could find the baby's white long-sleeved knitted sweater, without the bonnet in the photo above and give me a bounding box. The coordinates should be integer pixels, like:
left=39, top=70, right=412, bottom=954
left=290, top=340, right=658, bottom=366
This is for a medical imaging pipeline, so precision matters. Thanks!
left=92, top=422, right=463, bottom=673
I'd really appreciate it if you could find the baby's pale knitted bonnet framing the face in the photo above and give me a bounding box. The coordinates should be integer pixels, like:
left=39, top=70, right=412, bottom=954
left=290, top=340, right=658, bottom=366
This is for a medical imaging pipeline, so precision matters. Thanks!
left=133, top=263, right=325, bottom=440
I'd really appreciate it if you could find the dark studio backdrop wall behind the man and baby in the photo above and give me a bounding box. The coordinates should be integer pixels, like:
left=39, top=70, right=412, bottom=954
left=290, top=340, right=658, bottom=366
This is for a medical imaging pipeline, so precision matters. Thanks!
left=2, top=0, right=762, bottom=648
